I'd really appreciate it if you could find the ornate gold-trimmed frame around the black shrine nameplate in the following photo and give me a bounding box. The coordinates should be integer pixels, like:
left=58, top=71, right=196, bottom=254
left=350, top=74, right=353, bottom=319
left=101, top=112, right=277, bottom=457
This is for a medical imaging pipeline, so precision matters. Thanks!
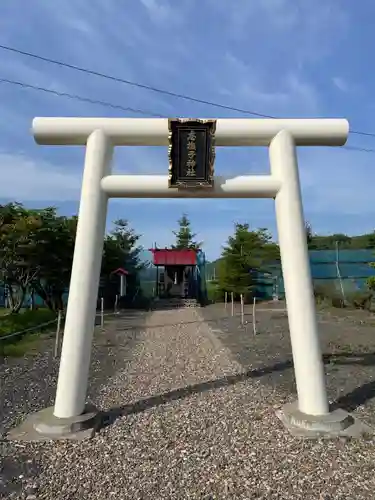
left=168, top=118, right=217, bottom=189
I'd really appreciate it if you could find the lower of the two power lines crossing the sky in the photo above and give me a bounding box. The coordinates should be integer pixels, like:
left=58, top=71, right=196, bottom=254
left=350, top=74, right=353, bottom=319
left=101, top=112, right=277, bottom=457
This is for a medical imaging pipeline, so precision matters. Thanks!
left=0, top=78, right=375, bottom=153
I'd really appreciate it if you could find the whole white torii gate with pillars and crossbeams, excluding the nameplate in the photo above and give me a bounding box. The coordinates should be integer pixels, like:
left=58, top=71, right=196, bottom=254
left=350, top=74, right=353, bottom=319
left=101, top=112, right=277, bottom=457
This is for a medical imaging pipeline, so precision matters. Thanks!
left=12, top=118, right=374, bottom=440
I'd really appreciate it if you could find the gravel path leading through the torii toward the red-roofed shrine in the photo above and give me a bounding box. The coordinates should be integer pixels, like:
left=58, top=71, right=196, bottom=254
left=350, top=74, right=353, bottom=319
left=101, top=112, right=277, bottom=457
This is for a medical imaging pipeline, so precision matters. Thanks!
left=0, top=309, right=375, bottom=500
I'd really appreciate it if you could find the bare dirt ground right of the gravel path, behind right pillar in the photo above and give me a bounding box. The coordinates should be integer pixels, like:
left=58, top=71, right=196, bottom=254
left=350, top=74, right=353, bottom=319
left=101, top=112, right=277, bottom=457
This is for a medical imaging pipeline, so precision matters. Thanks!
left=202, top=302, right=375, bottom=426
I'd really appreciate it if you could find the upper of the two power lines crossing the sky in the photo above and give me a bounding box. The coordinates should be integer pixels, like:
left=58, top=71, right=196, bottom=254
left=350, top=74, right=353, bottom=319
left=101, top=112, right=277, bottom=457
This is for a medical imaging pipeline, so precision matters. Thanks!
left=0, top=44, right=375, bottom=137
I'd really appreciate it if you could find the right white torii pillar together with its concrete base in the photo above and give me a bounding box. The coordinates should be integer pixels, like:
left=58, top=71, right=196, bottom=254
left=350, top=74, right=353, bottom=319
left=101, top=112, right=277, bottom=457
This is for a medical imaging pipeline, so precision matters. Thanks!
left=269, top=130, right=369, bottom=438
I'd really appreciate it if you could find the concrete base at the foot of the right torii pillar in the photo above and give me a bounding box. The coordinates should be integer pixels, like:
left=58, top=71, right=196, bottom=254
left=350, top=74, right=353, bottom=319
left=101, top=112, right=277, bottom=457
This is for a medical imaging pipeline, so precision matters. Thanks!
left=276, top=402, right=374, bottom=439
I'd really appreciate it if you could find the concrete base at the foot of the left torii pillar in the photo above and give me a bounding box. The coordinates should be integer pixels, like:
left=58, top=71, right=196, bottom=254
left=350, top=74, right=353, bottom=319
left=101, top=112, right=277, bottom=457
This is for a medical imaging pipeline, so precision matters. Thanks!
left=7, top=405, right=100, bottom=441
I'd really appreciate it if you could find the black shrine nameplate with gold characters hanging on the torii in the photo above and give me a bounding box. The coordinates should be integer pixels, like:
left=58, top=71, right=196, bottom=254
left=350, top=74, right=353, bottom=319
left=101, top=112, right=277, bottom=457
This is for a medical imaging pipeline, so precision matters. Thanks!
left=168, top=118, right=216, bottom=189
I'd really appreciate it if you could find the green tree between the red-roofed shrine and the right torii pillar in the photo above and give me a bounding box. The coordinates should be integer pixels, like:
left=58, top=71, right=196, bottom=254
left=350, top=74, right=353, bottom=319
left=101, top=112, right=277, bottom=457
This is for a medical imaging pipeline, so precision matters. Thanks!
left=218, top=224, right=279, bottom=296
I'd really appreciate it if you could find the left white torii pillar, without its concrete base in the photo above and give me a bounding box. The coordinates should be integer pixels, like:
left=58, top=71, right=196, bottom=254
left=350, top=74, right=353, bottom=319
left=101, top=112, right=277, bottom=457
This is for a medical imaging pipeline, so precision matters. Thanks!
left=54, top=130, right=113, bottom=418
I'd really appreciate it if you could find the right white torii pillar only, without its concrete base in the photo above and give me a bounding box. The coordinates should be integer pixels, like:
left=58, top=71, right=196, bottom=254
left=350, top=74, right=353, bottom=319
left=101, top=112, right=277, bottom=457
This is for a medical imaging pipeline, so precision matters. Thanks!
left=269, top=130, right=328, bottom=415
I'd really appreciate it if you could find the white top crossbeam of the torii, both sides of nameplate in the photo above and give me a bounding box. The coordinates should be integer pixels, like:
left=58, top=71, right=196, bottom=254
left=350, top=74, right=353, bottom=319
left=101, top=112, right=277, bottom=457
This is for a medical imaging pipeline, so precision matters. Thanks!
left=32, top=117, right=349, bottom=146
